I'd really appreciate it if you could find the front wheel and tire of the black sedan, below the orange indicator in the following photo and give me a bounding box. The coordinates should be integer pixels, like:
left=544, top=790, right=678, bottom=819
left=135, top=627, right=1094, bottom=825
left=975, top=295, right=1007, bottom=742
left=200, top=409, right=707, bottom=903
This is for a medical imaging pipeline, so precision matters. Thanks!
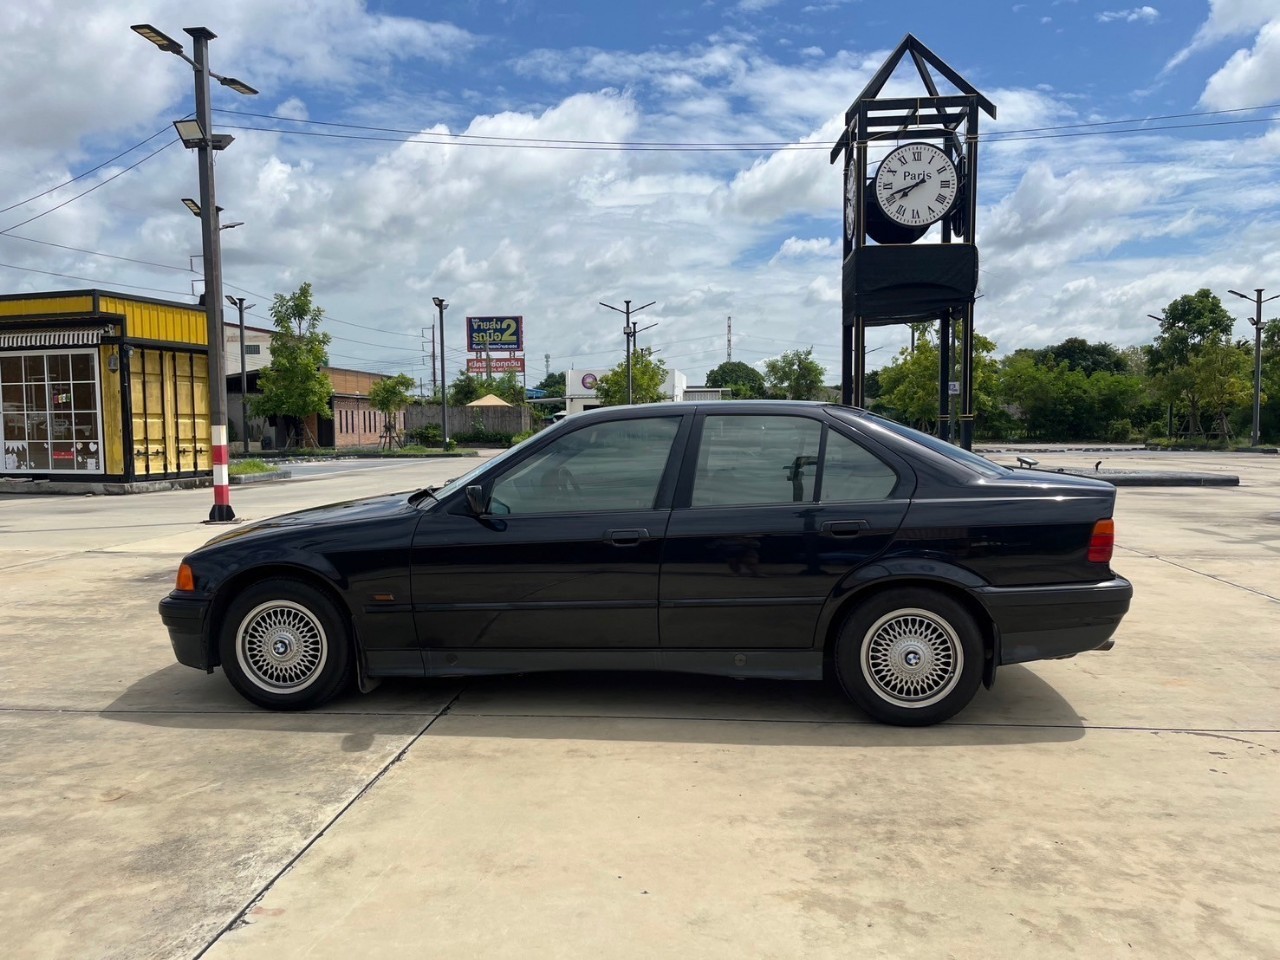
left=218, top=580, right=352, bottom=710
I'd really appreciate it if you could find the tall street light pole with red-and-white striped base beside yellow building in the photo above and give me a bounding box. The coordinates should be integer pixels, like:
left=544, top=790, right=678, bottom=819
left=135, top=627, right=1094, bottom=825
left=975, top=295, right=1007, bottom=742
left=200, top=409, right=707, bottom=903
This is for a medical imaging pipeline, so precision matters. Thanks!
left=131, top=23, right=257, bottom=524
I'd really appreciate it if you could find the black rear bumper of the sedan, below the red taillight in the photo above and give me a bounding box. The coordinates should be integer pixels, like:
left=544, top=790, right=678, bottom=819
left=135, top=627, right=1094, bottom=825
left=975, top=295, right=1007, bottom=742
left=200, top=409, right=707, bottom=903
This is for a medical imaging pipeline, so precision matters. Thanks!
left=974, top=577, right=1133, bottom=664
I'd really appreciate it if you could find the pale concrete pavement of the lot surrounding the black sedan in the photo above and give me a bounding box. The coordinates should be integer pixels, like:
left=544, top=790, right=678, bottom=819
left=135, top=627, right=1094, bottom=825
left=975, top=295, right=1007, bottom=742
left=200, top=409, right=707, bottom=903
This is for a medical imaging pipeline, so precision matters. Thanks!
left=0, top=451, right=1280, bottom=960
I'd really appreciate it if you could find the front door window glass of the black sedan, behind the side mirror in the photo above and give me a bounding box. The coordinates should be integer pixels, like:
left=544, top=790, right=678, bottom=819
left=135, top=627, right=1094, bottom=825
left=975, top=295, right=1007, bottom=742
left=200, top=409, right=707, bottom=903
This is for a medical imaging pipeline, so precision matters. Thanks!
left=489, top=417, right=680, bottom=516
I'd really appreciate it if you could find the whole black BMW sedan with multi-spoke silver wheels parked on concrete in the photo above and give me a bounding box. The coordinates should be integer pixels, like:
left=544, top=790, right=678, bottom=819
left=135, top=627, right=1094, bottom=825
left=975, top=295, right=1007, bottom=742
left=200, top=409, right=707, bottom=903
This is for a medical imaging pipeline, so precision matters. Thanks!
left=160, top=401, right=1133, bottom=724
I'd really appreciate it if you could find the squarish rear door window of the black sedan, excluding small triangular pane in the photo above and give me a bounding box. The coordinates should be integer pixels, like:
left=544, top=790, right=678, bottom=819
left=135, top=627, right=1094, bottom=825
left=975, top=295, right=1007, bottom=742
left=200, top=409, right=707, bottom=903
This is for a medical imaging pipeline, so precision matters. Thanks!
left=690, top=415, right=822, bottom=507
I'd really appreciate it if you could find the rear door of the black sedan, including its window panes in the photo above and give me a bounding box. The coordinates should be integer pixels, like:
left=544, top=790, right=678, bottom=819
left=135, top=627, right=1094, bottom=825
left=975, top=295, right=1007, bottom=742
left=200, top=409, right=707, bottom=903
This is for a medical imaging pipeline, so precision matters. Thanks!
left=659, top=410, right=915, bottom=649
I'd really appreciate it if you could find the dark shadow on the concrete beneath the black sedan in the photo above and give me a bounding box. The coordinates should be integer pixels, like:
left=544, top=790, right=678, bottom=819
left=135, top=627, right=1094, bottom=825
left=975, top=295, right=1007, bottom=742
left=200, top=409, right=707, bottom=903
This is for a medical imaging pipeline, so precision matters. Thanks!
left=100, top=664, right=1084, bottom=746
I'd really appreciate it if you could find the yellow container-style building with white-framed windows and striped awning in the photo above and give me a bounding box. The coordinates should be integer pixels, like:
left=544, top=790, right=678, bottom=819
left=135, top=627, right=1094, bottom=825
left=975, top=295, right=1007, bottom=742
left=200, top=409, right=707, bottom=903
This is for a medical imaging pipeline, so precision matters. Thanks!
left=0, top=291, right=212, bottom=484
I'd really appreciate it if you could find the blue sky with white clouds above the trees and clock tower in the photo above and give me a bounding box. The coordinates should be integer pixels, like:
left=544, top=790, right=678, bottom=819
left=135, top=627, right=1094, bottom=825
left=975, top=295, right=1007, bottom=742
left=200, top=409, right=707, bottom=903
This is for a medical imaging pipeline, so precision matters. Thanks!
left=0, top=0, right=1280, bottom=383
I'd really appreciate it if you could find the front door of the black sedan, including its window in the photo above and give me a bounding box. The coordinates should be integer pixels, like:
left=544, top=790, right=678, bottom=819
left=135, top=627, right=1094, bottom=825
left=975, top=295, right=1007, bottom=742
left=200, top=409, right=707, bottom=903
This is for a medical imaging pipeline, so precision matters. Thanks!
left=412, top=411, right=691, bottom=650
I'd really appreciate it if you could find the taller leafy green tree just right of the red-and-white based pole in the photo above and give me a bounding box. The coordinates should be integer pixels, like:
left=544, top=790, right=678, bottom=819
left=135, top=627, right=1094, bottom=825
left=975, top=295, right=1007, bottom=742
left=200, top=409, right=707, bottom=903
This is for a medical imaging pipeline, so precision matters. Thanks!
left=251, top=283, right=333, bottom=445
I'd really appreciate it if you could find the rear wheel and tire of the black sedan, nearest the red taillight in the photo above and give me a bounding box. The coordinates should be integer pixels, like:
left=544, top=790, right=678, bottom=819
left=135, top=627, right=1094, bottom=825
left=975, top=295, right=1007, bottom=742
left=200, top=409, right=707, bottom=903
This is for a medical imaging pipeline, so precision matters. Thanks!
left=835, top=588, right=983, bottom=727
